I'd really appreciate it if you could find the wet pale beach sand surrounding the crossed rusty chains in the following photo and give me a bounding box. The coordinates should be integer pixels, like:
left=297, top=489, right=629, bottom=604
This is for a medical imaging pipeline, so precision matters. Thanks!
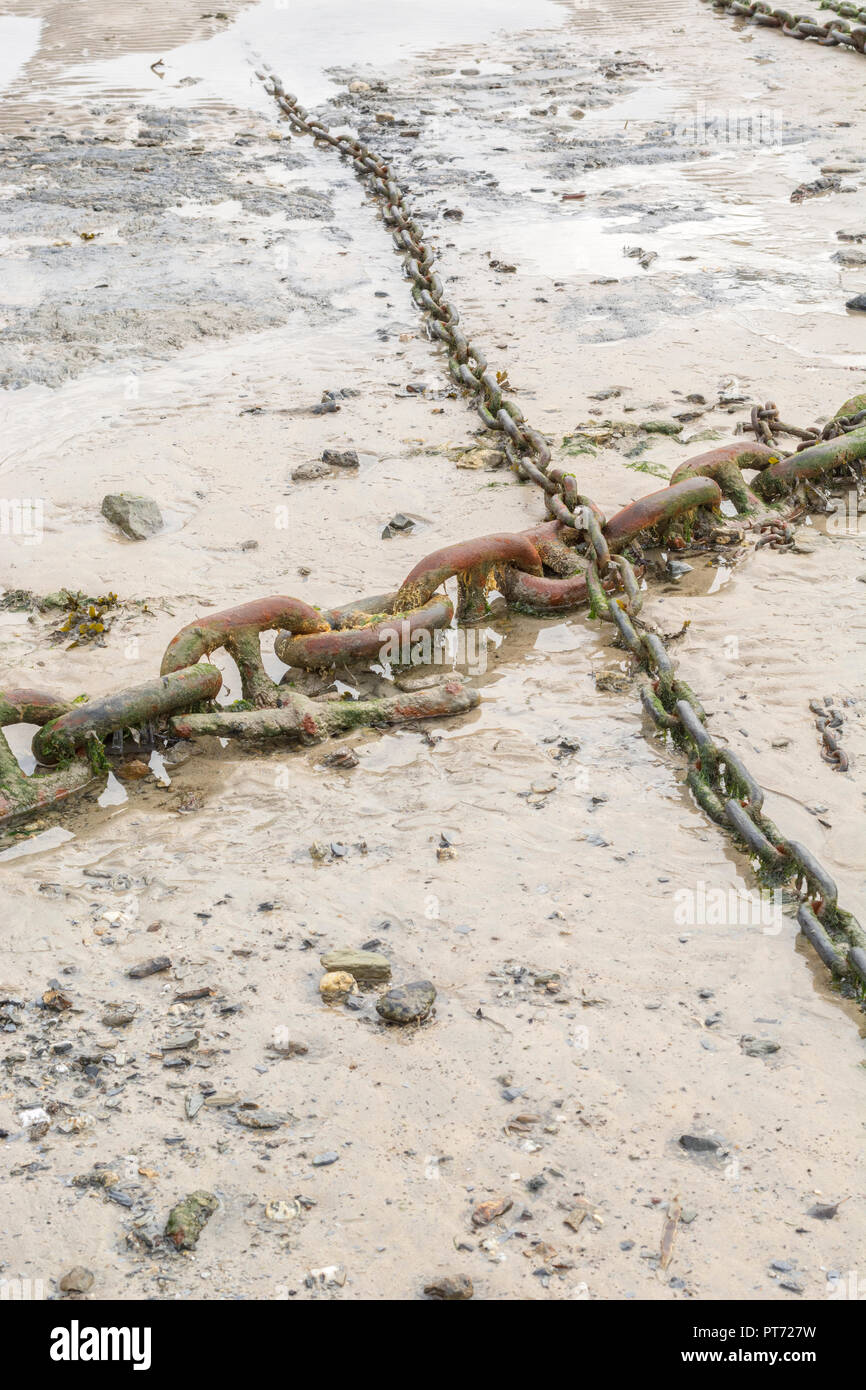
left=0, top=0, right=866, bottom=1300
